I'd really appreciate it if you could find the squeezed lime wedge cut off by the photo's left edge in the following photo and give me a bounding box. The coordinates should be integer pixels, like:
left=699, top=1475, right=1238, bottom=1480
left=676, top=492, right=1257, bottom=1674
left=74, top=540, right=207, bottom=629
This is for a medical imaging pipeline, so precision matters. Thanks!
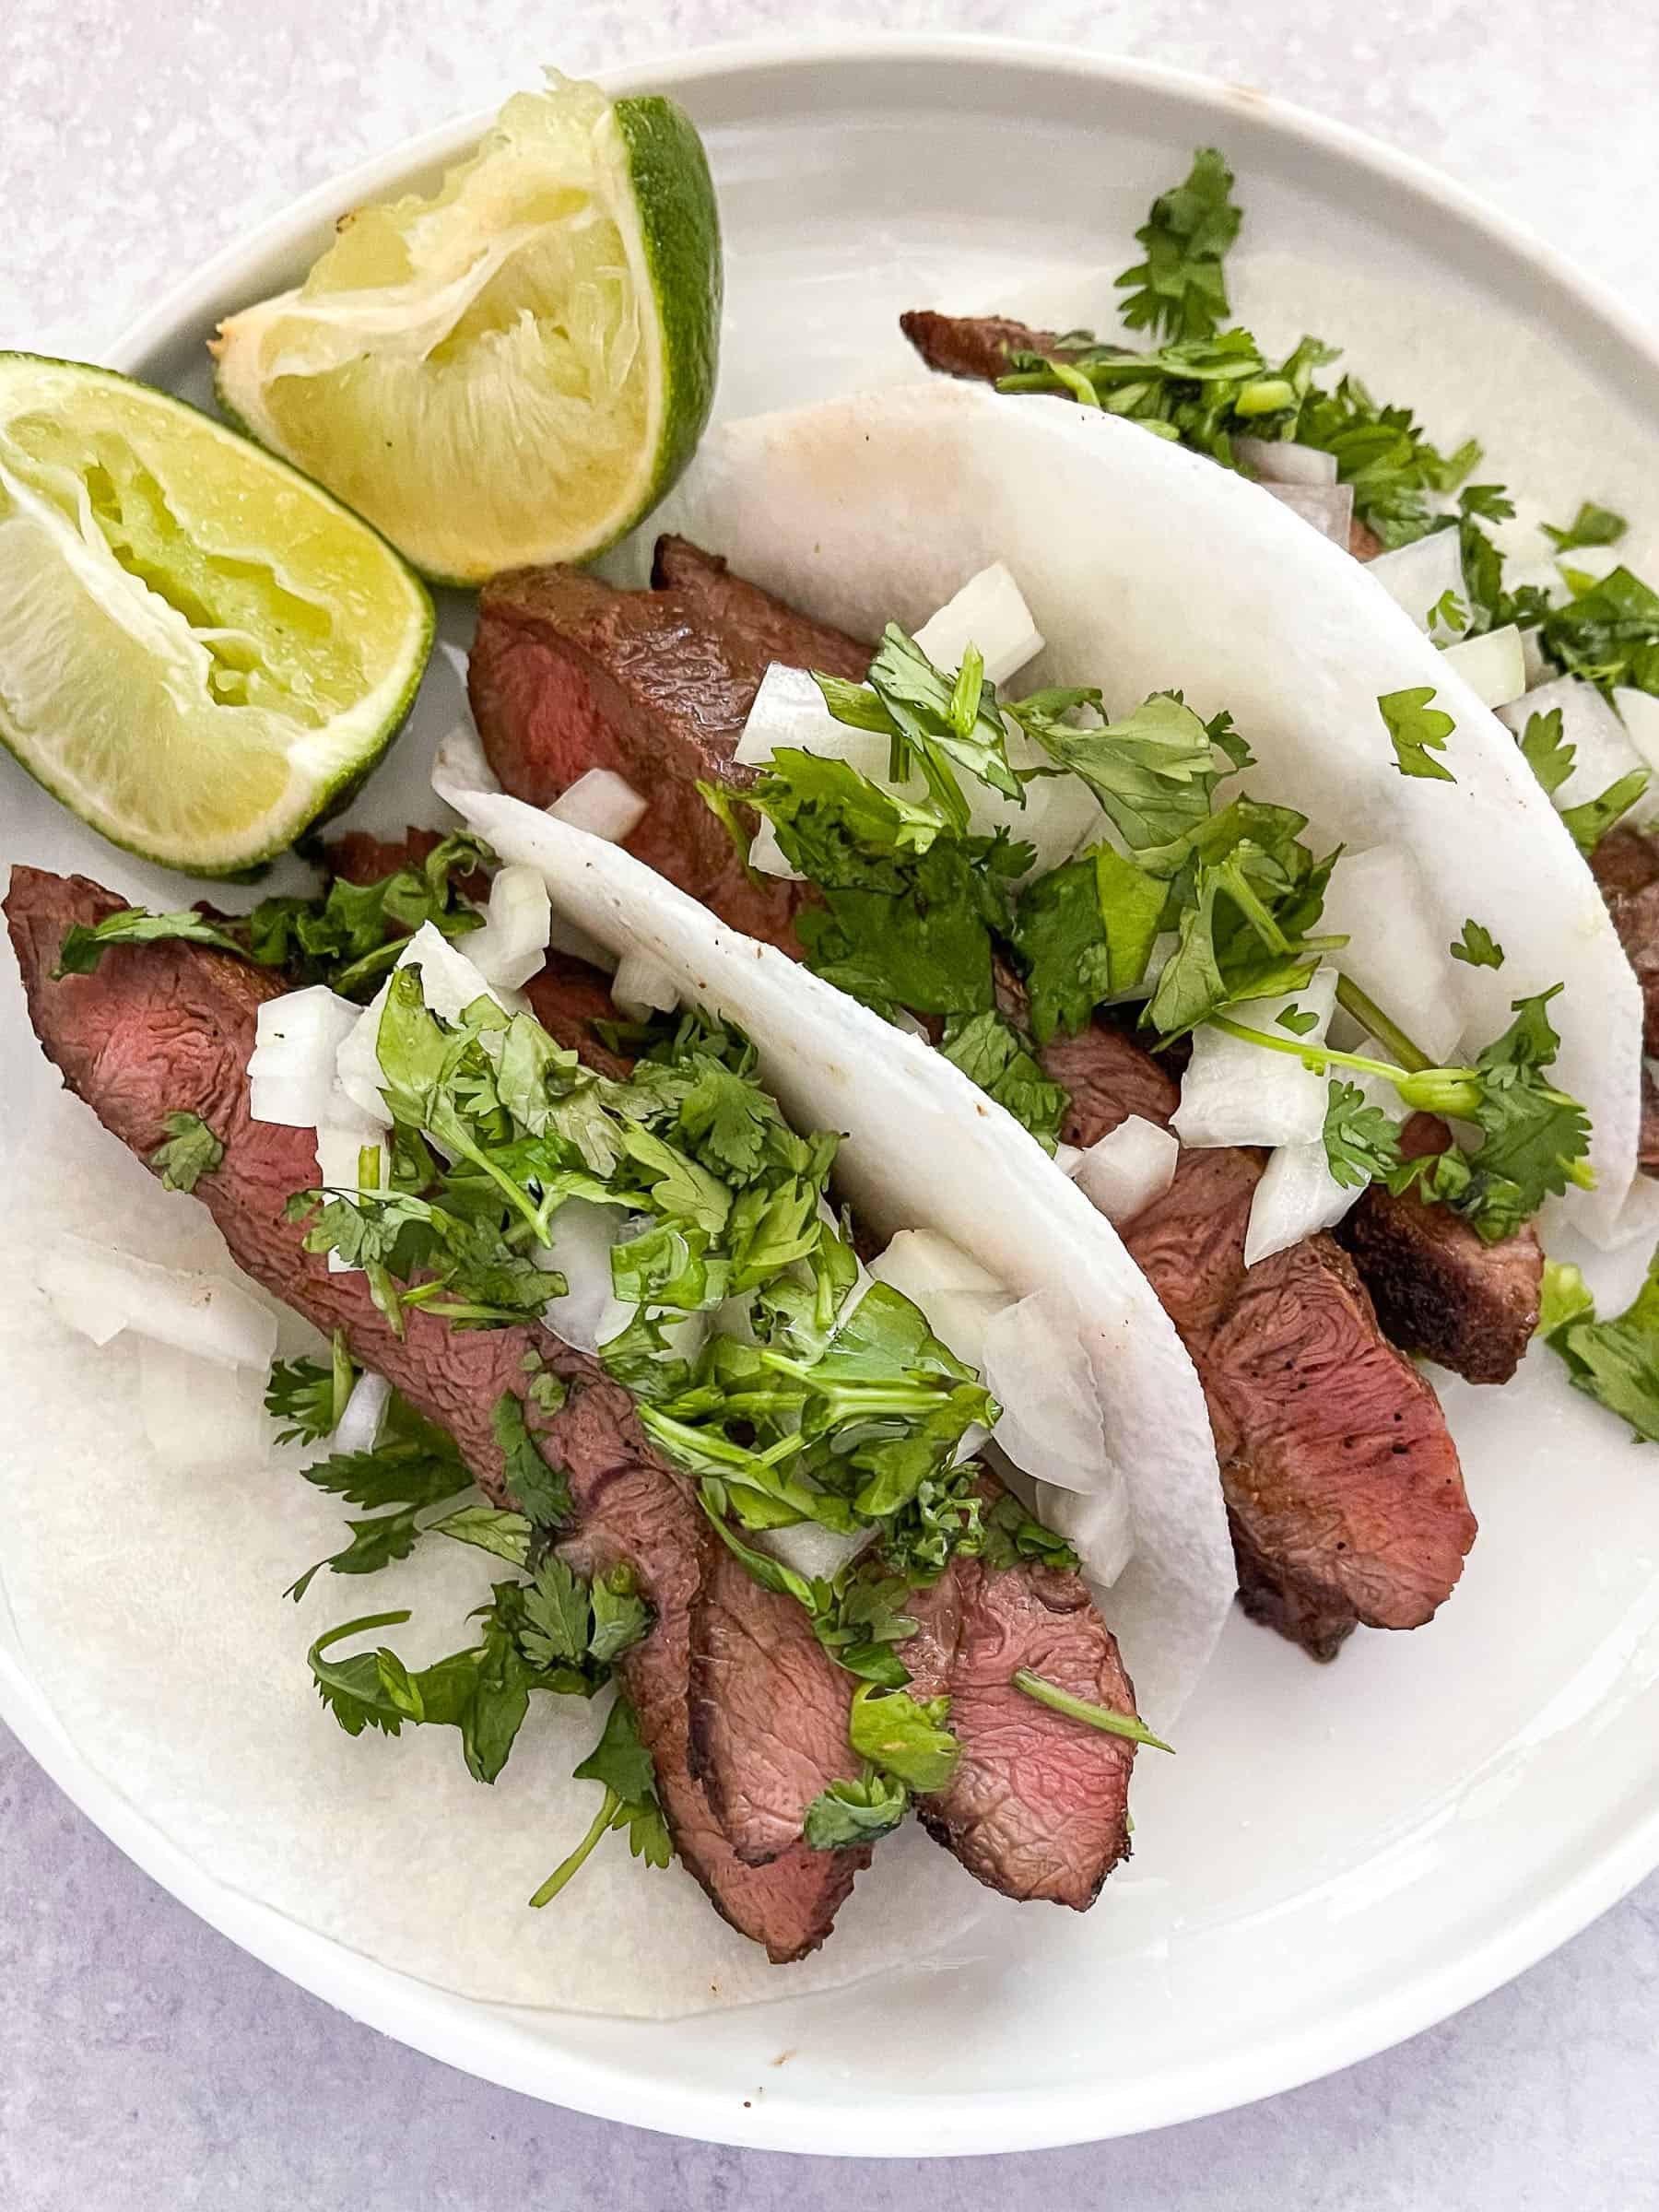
left=0, top=354, right=431, bottom=876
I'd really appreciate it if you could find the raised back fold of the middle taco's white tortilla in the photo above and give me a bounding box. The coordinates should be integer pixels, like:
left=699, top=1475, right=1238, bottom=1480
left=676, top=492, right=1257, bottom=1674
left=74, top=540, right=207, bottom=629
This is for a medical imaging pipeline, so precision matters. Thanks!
left=651, top=378, right=1641, bottom=1243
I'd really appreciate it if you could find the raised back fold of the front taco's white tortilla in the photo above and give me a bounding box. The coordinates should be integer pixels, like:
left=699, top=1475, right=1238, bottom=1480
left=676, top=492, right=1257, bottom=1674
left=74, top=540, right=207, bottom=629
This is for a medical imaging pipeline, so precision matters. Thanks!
left=433, top=778, right=1237, bottom=1727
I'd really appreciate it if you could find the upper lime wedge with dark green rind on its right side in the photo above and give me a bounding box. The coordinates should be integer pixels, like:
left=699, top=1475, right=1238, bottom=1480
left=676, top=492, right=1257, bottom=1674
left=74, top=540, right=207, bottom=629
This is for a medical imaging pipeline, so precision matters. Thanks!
left=212, top=71, right=721, bottom=584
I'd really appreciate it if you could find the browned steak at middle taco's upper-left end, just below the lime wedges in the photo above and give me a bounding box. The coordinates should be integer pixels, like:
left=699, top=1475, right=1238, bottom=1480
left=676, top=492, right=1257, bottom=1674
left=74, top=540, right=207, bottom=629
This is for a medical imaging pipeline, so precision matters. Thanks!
left=466, top=569, right=814, bottom=942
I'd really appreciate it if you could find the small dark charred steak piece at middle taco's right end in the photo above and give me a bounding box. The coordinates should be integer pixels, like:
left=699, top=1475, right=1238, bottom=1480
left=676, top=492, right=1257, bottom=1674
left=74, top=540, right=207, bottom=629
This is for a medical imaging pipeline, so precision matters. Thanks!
left=1338, top=1115, right=1544, bottom=1382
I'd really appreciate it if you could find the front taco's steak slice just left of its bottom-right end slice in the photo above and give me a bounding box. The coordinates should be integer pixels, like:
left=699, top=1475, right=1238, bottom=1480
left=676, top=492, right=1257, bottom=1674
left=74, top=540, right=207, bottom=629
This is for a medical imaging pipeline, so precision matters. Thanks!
left=690, top=1537, right=863, bottom=1867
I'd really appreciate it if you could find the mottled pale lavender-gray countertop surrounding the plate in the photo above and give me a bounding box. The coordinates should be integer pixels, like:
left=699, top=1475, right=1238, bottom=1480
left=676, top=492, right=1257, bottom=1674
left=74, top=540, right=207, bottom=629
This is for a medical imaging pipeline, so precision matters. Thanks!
left=0, top=0, right=1659, bottom=2212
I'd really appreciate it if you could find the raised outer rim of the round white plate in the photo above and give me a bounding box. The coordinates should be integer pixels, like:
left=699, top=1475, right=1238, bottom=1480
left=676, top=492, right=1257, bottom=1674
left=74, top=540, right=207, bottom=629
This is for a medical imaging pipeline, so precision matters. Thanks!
left=13, top=33, right=1659, bottom=2157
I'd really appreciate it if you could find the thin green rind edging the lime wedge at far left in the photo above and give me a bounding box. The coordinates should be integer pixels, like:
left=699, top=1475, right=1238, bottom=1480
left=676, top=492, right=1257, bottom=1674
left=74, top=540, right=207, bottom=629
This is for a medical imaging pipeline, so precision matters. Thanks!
left=0, top=347, right=438, bottom=880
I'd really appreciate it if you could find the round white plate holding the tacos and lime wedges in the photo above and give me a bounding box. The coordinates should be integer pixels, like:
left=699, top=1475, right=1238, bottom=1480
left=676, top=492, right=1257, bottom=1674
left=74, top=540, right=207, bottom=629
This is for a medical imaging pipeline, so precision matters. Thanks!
left=0, top=26, right=1659, bottom=2155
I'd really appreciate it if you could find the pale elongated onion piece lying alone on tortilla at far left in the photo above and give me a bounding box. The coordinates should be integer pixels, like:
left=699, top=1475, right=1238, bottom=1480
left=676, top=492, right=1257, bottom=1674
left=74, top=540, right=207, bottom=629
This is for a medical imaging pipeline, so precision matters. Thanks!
left=33, top=1234, right=276, bottom=1367
